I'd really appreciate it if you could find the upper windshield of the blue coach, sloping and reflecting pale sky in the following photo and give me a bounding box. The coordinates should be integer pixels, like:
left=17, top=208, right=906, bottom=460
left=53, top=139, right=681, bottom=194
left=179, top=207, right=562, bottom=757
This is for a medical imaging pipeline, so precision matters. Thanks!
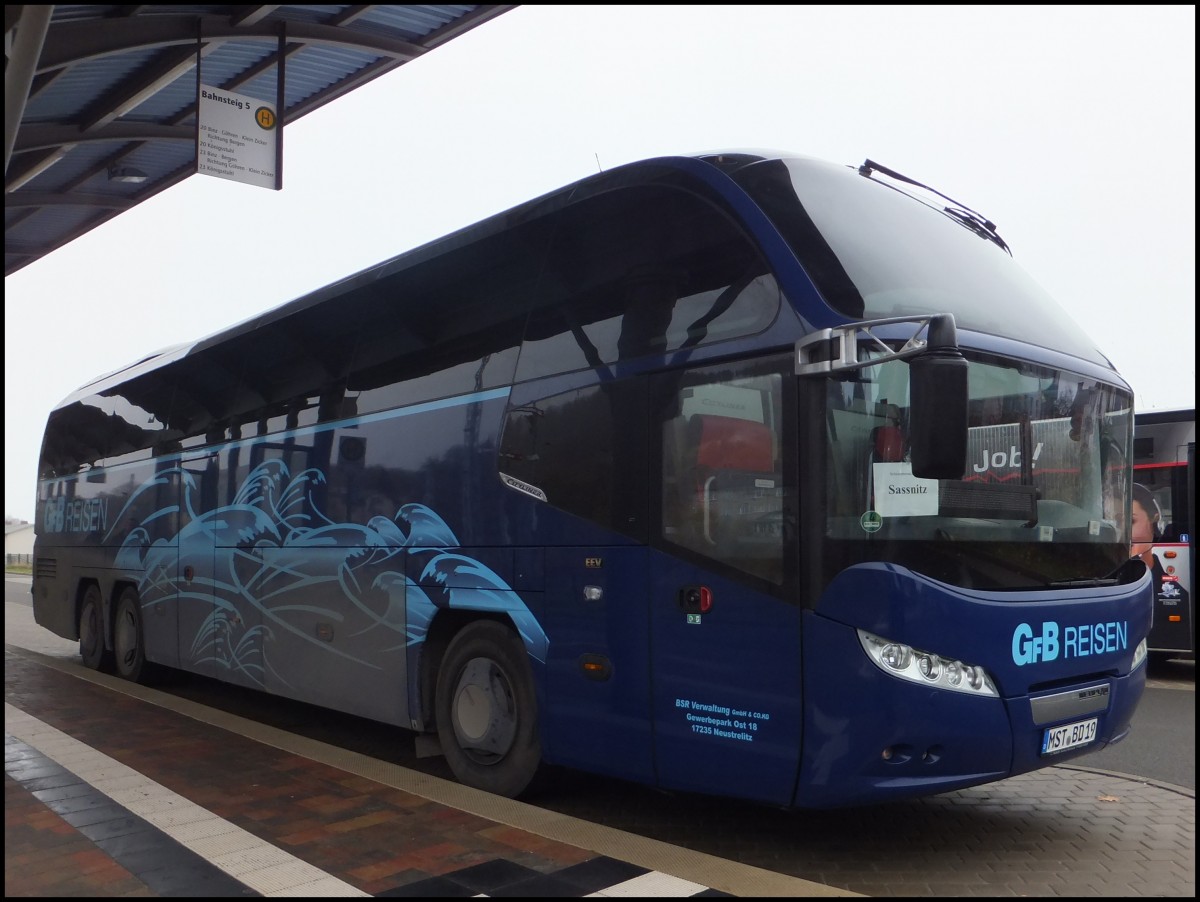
left=736, top=157, right=1110, bottom=368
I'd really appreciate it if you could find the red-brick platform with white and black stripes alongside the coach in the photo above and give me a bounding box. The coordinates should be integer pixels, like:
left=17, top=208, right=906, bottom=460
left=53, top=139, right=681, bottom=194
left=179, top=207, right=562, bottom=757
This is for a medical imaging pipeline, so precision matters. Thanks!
left=5, top=592, right=857, bottom=897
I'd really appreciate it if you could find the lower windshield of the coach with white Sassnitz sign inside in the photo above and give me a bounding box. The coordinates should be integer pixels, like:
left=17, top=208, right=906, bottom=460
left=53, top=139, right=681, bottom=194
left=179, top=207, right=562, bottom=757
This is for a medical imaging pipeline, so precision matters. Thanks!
left=820, top=356, right=1133, bottom=589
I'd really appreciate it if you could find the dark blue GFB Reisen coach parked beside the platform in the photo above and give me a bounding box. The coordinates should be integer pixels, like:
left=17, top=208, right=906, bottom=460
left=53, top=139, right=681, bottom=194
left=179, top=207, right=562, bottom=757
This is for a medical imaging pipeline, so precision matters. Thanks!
left=32, top=152, right=1152, bottom=808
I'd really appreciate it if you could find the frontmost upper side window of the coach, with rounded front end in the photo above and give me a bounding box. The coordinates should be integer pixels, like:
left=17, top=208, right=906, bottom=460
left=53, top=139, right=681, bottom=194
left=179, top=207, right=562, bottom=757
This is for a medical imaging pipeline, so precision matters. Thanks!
left=517, top=186, right=779, bottom=380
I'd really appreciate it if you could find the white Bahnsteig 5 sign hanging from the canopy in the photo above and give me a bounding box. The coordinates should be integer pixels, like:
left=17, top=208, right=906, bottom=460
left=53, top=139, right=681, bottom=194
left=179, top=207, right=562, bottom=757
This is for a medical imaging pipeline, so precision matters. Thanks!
left=196, top=84, right=278, bottom=188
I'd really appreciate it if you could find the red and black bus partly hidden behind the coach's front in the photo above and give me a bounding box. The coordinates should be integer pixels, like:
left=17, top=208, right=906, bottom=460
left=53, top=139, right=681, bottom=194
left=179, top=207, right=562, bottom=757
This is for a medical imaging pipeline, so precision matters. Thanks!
left=1134, top=408, right=1196, bottom=657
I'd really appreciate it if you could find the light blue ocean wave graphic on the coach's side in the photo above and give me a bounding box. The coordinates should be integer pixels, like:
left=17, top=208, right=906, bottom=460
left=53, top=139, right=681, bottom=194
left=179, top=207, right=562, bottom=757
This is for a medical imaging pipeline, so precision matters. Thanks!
left=115, top=461, right=550, bottom=687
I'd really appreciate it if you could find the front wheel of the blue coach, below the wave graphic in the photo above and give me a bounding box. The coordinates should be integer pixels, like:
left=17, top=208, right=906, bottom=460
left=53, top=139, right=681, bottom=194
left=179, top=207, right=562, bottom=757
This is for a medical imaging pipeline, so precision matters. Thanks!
left=434, top=620, right=541, bottom=799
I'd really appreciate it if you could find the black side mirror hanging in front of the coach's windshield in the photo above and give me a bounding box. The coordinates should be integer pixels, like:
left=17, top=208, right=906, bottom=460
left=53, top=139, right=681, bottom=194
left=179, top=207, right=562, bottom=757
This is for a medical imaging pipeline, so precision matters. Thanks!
left=908, top=317, right=967, bottom=480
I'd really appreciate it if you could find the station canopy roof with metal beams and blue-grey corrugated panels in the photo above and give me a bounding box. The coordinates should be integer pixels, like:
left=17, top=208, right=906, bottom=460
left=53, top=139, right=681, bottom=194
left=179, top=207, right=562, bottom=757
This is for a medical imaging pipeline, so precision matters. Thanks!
left=4, top=4, right=514, bottom=276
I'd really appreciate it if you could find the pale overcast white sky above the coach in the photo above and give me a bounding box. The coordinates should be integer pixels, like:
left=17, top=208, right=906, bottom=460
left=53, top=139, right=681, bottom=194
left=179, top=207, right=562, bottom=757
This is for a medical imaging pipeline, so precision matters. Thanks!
left=4, top=5, right=1195, bottom=522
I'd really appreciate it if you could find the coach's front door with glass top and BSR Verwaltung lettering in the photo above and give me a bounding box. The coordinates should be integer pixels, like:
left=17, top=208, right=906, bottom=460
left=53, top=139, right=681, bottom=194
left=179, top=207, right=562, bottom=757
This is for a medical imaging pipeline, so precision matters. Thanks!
left=648, top=360, right=802, bottom=805
